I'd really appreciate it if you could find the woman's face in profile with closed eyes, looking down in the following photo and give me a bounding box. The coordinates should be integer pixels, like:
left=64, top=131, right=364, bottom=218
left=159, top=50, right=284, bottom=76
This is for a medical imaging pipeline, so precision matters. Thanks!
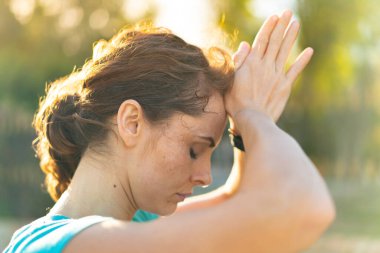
left=130, top=94, right=226, bottom=215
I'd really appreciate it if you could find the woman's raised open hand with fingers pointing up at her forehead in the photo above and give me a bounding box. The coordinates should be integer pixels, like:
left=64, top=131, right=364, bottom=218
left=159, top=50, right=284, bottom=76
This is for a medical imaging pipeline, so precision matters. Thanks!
left=224, top=11, right=313, bottom=128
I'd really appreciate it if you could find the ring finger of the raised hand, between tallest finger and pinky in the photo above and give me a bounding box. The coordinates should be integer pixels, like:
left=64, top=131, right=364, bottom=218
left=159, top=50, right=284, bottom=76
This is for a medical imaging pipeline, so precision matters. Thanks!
left=276, top=21, right=300, bottom=71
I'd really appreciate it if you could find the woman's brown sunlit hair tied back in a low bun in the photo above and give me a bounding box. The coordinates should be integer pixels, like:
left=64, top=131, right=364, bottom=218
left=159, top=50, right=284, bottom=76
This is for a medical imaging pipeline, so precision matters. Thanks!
left=33, top=26, right=234, bottom=200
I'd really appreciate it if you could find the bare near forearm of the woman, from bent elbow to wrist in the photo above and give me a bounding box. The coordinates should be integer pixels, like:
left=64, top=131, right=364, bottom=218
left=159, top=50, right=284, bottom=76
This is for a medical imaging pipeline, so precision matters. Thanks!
left=230, top=111, right=334, bottom=252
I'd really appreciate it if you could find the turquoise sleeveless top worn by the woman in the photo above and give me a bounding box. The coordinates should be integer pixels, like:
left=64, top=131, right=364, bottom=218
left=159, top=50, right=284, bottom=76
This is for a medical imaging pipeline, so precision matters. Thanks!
left=3, top=210, right=159, bottom=253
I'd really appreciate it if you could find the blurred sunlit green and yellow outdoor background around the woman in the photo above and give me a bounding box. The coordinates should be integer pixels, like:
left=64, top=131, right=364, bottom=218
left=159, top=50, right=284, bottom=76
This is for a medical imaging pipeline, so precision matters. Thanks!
left=0, top=0, right=380, bottom=253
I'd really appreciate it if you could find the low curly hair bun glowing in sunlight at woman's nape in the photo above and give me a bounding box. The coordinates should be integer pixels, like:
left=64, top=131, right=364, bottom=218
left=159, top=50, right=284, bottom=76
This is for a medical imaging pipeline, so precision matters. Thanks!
left=33, top=90, right=88, bottom=200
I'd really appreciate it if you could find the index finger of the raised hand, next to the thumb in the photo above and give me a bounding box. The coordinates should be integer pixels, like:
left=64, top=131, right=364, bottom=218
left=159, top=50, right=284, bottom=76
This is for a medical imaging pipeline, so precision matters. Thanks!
left=252, top=15, right=278, bottom=59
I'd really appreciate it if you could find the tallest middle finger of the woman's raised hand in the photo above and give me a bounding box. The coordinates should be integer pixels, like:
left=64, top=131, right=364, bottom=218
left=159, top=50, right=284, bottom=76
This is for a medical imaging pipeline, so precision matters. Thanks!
left=265, top=10, right=292, bottom=60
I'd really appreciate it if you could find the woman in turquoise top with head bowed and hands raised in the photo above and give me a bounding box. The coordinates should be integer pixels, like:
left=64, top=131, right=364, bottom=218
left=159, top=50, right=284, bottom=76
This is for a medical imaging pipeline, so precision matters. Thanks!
left=5, top=11, right=334, bottom=253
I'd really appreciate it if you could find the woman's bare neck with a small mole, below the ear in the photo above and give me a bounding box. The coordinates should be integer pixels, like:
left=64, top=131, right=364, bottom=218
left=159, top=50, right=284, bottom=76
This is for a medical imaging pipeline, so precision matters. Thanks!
left=50, top=149, right=137, bottom=220
